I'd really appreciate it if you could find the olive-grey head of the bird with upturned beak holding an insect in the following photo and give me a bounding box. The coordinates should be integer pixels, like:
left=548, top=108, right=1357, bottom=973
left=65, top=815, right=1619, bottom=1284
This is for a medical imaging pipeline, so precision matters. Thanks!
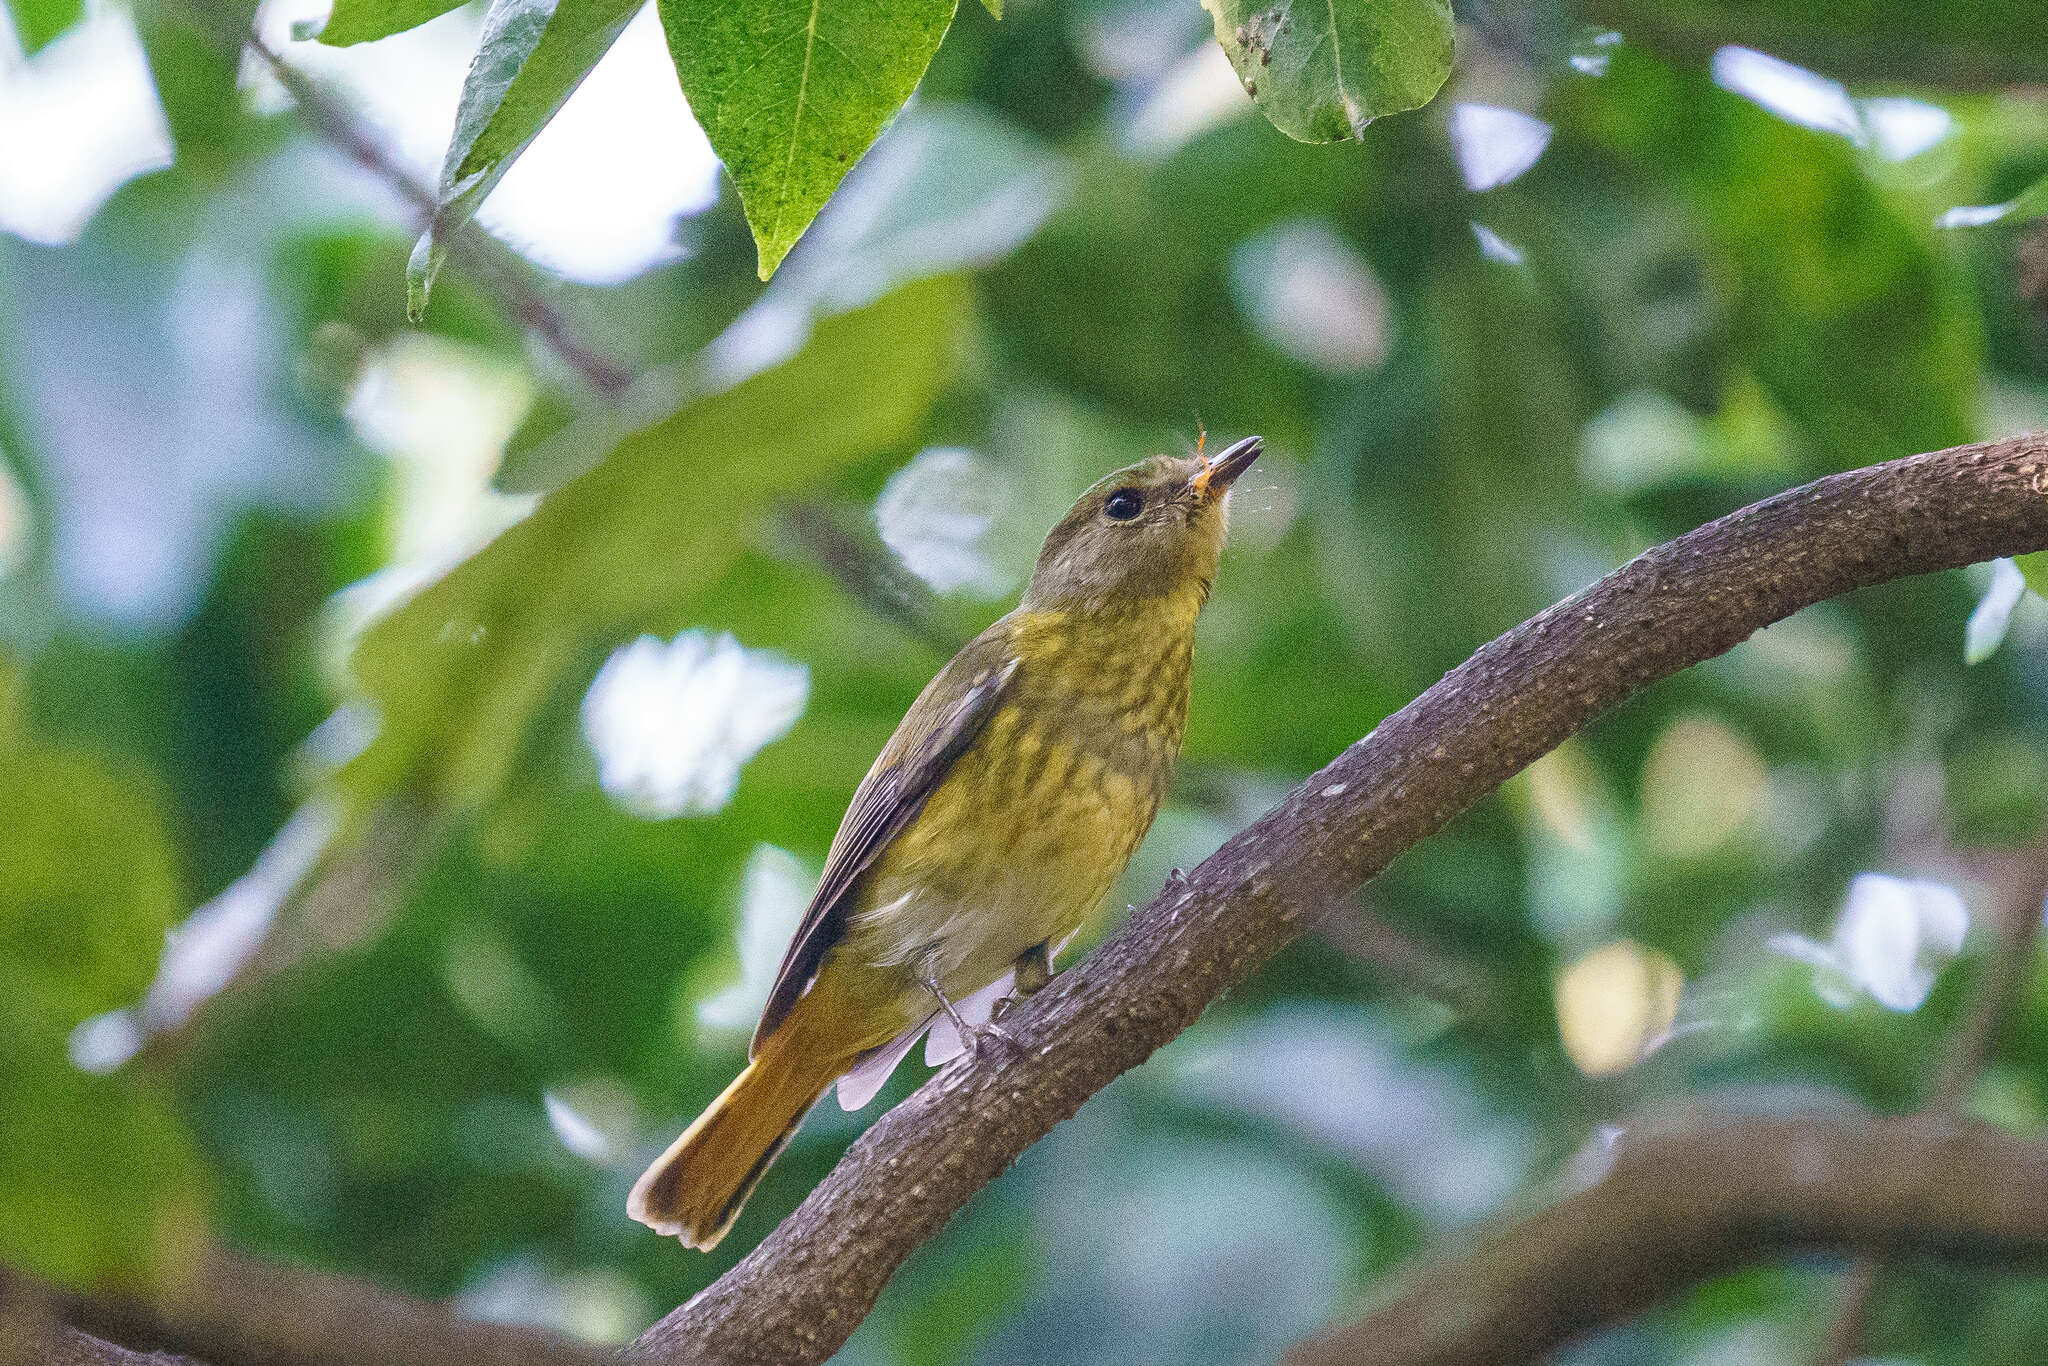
left=1024, top=436, right=1262, bottom=612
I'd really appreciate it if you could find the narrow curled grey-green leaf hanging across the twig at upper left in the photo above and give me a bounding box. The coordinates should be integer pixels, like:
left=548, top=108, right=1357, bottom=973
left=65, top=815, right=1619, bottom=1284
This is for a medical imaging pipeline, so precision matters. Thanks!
left=406, top=0, right=645, bottom=322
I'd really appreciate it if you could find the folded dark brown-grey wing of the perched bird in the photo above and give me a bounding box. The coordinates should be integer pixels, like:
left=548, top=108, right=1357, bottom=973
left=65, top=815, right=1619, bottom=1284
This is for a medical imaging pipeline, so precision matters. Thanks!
left=750, top=631, right=1018, bottom=1053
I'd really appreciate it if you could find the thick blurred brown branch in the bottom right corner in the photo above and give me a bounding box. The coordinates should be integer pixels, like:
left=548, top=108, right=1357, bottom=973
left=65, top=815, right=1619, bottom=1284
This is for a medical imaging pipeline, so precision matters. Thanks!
left=1282, top=1112, right=2048, bottom=1366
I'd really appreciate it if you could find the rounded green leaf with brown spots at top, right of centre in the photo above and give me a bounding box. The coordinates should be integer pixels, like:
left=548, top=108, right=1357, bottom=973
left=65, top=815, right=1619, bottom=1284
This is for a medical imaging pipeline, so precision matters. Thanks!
left=1202, top=0, right=1456, bottom=141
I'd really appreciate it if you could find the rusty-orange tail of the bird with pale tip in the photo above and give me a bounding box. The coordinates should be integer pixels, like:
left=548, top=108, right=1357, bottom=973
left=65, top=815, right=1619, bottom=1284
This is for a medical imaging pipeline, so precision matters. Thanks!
left=627, top=1020, right=848, bottom=1251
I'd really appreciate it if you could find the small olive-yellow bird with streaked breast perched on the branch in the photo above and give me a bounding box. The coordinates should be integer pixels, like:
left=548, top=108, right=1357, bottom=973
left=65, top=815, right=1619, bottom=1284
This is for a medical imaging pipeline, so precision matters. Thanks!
left=627, top=436, right=1260, bottom=1249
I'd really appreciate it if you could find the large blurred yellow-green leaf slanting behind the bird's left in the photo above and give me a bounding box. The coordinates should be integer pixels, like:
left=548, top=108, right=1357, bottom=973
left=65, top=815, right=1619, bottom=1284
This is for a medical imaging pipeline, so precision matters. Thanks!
left=340, top=276, right=967, bottom=807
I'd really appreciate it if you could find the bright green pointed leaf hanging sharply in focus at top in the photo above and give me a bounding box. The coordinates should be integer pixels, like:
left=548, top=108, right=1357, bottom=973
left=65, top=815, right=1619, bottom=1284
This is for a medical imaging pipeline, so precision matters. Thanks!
left=662, top=0, right=954, bottom=281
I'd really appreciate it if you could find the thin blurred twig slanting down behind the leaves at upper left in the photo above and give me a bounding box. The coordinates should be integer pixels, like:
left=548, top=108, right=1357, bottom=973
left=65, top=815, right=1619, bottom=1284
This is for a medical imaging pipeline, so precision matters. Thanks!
left=244, top=33, right=633, bottom=399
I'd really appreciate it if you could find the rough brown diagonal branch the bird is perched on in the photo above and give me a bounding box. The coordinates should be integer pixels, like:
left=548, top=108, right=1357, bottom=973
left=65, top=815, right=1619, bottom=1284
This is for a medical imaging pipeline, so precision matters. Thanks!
left=635, top=434, right=2048, bottom=1366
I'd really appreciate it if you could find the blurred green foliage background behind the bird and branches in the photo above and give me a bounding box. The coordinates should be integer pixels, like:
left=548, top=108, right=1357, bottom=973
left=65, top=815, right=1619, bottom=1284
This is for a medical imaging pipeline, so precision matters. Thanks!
left=0, top=0, right=2048, bottom=1364
